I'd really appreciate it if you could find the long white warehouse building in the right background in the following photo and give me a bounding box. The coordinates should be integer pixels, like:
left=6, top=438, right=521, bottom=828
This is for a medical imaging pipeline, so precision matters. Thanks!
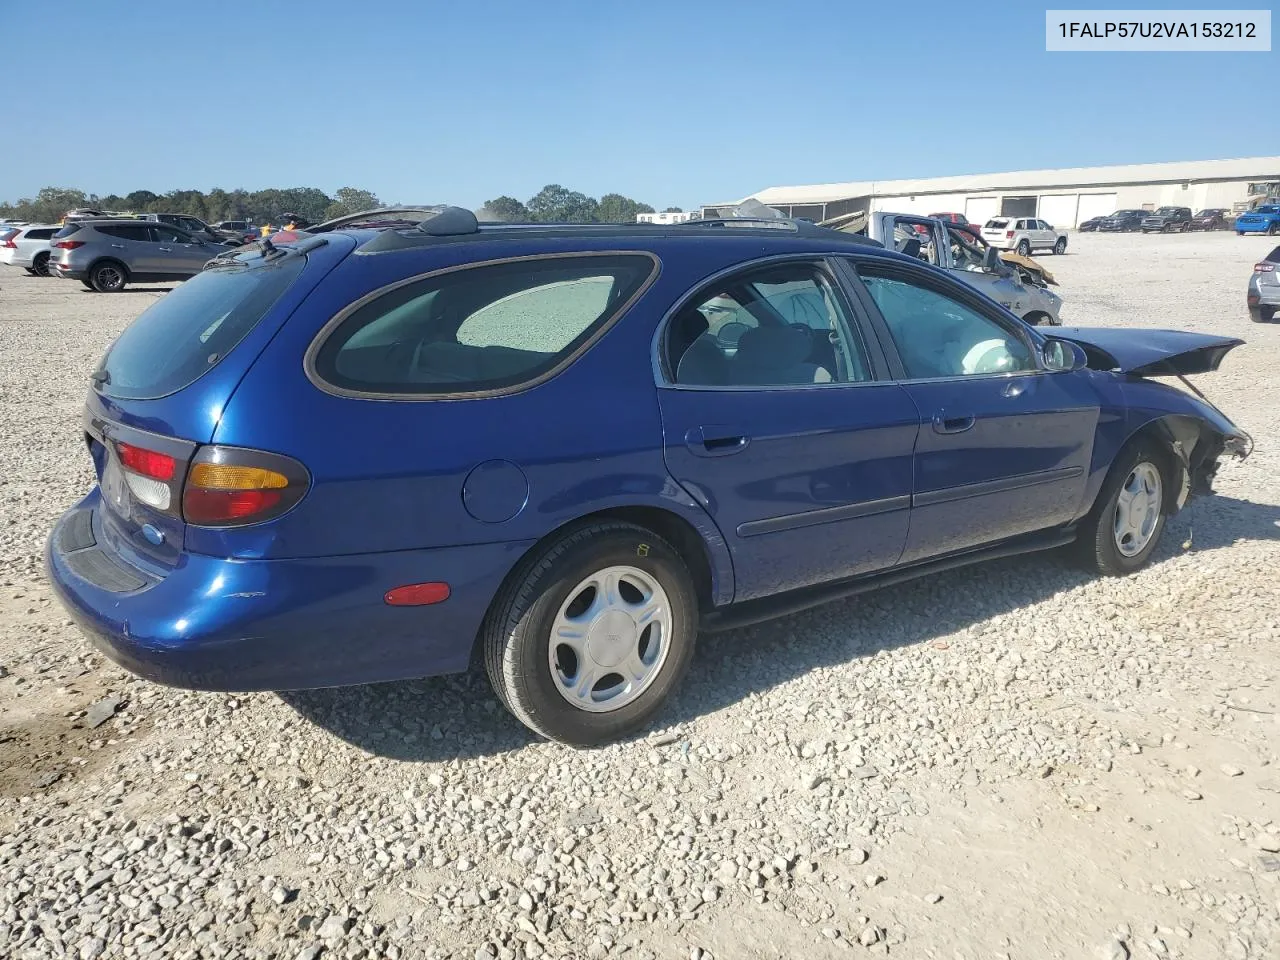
left=703, top=156, right=1280, bottom=229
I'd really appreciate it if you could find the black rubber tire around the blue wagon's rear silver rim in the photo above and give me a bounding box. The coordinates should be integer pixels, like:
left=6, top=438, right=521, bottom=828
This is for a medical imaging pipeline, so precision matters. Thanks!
left=480, top=521, right=698, bottom=746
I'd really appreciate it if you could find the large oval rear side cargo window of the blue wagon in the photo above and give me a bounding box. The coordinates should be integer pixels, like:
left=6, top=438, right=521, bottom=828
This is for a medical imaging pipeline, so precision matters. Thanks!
left=312, top=253, right=655, bottom=394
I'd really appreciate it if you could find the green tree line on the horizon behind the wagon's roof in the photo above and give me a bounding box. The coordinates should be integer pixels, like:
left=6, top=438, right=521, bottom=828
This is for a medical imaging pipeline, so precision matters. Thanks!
left=0, top=183, right=678, bottom=223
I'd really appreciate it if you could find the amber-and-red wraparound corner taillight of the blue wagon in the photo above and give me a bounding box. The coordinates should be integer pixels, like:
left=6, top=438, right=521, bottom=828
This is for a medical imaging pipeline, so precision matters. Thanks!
left=182, top=447, right=310, bottom=526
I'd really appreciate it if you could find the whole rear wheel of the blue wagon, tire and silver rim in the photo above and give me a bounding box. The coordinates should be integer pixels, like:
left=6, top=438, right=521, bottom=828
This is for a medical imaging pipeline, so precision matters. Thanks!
left=481, top=521, right=698, bottom=746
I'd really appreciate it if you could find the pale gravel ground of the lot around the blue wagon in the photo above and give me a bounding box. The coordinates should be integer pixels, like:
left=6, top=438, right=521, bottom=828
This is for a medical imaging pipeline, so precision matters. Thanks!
left=0, top=234, right=1280, bottom=960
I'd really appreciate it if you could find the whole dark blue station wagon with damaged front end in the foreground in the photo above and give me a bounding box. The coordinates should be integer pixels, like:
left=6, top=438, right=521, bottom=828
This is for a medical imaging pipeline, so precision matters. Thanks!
left=47, top=207, right=1251, bottom=744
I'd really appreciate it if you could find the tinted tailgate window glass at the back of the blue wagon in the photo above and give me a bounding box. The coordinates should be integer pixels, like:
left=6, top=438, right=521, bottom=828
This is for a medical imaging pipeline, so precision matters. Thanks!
left=100, top=256, right=306, bottom=399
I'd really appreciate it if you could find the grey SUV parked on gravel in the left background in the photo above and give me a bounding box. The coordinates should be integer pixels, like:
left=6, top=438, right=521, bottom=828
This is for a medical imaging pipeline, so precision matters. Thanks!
left=50, top=220, right=228, bottom=293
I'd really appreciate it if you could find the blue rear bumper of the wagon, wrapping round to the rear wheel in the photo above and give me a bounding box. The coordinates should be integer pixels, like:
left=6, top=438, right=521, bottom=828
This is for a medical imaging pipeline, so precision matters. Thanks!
left=45, top=488, right=531, bottom=691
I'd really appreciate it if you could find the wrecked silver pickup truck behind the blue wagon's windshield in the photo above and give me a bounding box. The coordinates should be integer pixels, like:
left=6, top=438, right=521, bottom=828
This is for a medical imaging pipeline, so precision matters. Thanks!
left=867, top=211, right=1062, bottom=326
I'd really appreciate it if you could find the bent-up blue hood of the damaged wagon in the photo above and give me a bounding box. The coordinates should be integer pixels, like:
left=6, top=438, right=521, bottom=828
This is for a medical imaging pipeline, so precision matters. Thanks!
left=1053, top=326, right=1244, bottom=376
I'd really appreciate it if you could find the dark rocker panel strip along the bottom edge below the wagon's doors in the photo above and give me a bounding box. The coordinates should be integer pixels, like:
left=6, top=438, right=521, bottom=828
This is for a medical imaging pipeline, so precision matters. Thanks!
left=699, top=527, right=1075, bottom=634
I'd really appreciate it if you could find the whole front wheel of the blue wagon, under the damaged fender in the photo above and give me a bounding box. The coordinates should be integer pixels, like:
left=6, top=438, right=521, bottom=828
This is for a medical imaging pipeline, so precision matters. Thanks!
left=1078, top=442, right=1167, bottom=576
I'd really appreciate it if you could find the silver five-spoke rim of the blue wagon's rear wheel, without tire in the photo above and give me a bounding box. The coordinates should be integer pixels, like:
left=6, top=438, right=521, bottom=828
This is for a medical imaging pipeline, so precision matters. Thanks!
left=548, top=567, right=671, bottom=713
